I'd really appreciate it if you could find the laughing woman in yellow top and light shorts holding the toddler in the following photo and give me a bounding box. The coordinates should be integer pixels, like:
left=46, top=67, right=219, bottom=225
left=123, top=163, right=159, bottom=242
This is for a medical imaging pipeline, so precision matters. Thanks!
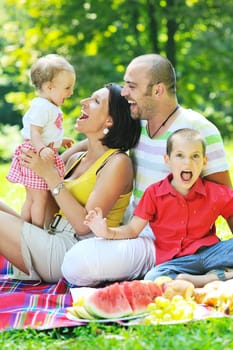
left=0, top=84, right=141, bottom=282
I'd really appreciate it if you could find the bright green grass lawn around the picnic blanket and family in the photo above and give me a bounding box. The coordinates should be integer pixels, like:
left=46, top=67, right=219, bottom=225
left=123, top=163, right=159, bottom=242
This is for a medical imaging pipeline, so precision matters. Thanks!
left=0, top=144, right=233, bottom=350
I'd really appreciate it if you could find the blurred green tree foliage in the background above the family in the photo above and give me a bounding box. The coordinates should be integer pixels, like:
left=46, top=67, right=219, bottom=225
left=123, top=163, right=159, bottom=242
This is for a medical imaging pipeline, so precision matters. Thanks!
left=0, top=0, right=233, bottom=138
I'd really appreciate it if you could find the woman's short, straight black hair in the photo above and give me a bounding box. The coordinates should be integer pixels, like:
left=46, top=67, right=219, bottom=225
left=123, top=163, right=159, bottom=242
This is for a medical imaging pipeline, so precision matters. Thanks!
left=101, top=83, right=141, bottom=151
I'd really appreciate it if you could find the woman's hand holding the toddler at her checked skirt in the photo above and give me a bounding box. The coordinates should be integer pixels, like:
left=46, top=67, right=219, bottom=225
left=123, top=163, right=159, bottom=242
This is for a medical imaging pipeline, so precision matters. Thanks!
left=20, top=148, right=55, bottom=179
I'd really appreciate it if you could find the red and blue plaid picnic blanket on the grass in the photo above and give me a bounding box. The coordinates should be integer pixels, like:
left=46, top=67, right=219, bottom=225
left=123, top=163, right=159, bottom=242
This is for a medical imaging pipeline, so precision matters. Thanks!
left=0, top=255, right=84, bottom=331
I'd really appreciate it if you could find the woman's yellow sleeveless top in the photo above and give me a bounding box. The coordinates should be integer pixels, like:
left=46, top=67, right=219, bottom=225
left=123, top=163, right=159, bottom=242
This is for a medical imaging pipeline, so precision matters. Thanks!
left=60, top=148, right=132, bottom=227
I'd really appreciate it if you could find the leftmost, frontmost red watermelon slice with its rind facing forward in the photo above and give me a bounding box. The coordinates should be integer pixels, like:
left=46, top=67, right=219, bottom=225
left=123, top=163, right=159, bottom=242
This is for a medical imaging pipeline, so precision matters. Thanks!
left=84, top=282, right=132, bottom=318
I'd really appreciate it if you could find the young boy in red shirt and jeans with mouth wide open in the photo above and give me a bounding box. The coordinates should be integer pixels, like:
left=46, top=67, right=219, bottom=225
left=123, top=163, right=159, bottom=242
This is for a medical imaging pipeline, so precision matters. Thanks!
left=85, top=128, right=233, bottom=286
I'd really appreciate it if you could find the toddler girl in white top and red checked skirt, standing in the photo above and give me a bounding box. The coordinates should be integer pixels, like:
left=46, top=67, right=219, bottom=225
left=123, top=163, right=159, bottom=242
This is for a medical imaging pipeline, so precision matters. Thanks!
left=7, top=54, right=75, bottom=227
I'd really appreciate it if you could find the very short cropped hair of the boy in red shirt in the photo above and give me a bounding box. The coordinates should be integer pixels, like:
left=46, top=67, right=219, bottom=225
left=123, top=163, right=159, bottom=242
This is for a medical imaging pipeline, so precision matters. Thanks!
left=166, top=128, right=206, bottom=156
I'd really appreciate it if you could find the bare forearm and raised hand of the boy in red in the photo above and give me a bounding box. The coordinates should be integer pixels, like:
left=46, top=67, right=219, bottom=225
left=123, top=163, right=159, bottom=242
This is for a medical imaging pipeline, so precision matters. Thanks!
left=84, top=208, right=148, bottom=239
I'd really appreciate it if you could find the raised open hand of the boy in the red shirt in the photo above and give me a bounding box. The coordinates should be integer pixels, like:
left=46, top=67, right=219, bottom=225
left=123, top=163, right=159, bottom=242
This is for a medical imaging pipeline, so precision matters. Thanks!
left=84, top=208, right=111, bottom=239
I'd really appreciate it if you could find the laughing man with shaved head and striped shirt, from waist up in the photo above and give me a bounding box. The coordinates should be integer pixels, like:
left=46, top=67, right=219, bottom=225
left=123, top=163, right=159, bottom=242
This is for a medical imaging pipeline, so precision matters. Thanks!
left=122, top=54, right=231, bottom=217
